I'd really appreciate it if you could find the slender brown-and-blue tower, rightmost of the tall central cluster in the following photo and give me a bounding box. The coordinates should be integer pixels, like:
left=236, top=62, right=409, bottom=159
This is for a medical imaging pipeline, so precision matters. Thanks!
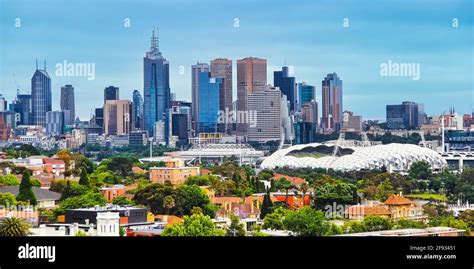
left=321, top=73, right=342, bottom=130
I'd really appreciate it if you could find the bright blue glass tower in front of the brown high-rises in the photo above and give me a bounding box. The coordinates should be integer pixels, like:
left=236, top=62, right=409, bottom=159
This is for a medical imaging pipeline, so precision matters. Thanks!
left=197, top=72, right=225, bottom=133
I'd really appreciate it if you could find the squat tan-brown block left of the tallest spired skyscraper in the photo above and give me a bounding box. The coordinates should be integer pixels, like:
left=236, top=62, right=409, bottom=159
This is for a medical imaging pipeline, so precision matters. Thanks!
left=104, top=100, right=133, bottom=135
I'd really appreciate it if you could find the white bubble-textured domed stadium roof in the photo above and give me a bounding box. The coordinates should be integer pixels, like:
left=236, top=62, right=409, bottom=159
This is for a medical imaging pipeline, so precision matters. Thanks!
left=261, top=143, right=446, bottom=171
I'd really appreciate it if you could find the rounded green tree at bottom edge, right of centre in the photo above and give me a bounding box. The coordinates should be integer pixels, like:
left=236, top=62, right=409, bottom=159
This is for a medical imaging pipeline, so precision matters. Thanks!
left=283, top=207, right=340, bottom=236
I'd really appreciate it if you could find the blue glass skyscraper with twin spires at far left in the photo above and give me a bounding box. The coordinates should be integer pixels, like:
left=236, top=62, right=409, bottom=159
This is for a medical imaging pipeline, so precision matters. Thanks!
left=31, top=62, right=51, bottom=127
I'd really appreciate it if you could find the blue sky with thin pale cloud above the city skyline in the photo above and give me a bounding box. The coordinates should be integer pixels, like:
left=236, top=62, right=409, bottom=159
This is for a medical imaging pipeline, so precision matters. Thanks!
left=0, top=0, right=474, bottom=119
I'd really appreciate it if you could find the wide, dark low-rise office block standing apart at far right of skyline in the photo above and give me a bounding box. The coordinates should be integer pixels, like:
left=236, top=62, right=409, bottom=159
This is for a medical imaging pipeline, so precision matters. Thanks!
left=386, top=101, right=425, bottom=129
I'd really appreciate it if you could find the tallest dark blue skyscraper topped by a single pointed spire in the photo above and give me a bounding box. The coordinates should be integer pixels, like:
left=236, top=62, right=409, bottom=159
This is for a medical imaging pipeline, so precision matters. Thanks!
left=143, top=30, right=170, bottom=135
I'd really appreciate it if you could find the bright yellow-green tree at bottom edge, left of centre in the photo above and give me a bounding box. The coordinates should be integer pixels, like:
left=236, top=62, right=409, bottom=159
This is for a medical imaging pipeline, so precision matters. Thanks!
left=161, top=214, right=225, bottom=236
